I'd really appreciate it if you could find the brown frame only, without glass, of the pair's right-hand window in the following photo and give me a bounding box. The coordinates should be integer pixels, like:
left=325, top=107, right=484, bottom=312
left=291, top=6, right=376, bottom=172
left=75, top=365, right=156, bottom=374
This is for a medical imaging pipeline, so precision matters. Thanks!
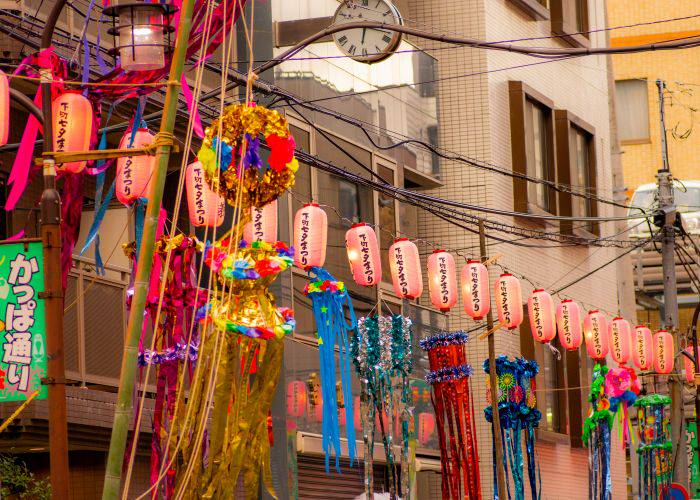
left=554, top=109, right=600, bottom=239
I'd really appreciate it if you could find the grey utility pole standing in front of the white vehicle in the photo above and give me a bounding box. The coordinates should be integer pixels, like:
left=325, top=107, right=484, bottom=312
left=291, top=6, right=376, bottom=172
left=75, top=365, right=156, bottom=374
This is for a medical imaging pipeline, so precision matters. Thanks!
left=656, top=80, right=688, bottom=488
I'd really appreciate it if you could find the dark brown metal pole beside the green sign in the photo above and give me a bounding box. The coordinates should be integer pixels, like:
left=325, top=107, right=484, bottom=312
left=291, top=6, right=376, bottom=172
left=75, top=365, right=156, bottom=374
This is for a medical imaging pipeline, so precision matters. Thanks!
left=40, top=0, right=69, bottom=500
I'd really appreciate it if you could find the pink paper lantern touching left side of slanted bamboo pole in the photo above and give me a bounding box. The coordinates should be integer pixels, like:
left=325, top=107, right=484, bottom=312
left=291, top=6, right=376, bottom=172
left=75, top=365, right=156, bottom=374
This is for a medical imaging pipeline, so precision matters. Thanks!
left=116, top=128, right=156, bottom=205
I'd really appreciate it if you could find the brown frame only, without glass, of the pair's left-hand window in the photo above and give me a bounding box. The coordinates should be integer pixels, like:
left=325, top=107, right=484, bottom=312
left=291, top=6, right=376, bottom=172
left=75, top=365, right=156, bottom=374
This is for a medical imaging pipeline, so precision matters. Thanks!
left=508, top=80, right=558, bottom=219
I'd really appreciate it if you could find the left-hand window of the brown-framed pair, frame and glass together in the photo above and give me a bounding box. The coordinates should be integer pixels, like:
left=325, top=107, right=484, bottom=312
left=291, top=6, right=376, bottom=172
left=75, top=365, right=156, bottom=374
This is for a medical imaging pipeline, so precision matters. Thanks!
left=509, top=82, right=557, bottom=213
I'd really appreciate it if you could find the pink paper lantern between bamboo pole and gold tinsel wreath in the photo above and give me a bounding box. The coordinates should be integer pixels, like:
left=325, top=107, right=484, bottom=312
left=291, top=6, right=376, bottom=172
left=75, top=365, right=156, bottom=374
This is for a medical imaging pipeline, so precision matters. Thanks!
left=185, top=161, right=226, bottom=227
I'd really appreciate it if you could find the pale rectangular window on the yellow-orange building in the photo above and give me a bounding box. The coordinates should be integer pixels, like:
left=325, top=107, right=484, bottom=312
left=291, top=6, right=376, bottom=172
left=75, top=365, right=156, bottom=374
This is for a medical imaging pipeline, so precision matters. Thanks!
left=615, top=80, right=649, bottom=143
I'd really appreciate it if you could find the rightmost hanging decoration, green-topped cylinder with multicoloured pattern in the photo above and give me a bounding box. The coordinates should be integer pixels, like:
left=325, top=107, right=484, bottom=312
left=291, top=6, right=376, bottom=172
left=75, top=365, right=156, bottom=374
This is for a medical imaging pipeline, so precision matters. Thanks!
left=635, top=394, right=673, bottom=500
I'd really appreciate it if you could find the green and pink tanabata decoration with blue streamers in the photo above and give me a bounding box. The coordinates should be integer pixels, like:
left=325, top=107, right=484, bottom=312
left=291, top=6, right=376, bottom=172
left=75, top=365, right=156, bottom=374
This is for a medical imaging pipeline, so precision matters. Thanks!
left=583, top=364, right=640, bottom=500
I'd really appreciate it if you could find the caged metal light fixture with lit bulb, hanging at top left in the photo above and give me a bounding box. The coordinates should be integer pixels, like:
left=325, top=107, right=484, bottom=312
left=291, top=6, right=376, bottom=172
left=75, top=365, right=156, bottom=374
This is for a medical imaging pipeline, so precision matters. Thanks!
left=104, top=0, right=177, bottom=71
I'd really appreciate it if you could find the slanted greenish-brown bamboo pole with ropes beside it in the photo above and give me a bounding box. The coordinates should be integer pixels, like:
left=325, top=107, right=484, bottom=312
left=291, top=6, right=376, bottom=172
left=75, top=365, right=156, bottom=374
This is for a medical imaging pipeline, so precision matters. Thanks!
left=102, top=0, right=194, bottom=500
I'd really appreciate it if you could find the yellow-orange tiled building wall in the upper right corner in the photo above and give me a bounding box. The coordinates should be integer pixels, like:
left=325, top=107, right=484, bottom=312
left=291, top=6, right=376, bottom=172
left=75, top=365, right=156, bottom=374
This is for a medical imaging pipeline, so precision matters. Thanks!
left=608, top=0, right=700, bottom=190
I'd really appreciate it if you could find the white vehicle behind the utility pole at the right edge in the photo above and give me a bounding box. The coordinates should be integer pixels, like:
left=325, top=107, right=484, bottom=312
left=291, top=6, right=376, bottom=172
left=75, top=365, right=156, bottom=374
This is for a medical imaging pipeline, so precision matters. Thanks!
left=628, top=181, right=700, bottom=238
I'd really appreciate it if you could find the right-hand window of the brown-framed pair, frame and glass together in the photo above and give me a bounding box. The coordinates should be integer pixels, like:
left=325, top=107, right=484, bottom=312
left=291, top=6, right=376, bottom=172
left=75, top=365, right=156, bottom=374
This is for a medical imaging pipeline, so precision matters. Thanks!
left=554, top=109, right=599, bottom=237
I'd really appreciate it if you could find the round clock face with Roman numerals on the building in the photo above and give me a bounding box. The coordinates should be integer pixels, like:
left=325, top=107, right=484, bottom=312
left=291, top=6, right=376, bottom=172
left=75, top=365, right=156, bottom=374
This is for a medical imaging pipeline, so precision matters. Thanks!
left=333, top=0, right=402, bottom=63
